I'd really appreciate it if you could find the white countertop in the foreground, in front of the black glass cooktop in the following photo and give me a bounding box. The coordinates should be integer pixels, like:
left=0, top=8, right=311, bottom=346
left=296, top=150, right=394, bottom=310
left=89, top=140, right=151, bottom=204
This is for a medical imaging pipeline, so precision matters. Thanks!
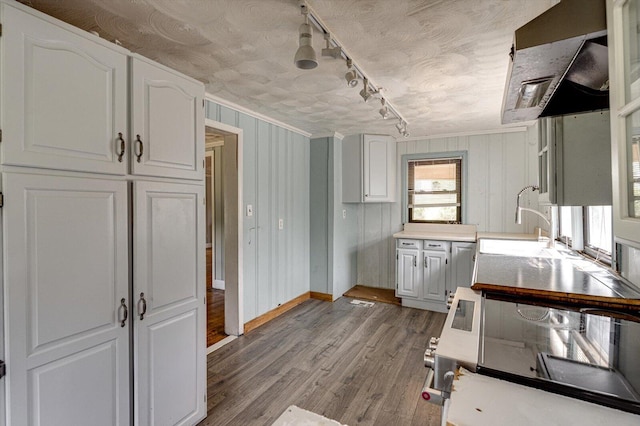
left=443, top=368, right=640, bottom=426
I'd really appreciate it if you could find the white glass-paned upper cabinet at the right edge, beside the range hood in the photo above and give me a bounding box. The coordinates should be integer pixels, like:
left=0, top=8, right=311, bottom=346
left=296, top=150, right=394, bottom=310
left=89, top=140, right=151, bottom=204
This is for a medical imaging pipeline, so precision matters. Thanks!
left=607, top=0, right=640, bottom=248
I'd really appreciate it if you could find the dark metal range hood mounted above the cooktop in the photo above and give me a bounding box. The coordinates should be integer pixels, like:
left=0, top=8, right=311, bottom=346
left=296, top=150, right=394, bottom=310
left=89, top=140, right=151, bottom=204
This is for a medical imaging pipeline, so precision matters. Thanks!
left=502, top=0, right=609, bottom=124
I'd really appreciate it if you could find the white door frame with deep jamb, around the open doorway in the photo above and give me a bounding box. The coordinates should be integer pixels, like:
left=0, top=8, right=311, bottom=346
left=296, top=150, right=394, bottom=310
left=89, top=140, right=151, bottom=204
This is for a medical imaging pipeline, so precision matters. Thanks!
left=204, top=118, right=244, bottom=336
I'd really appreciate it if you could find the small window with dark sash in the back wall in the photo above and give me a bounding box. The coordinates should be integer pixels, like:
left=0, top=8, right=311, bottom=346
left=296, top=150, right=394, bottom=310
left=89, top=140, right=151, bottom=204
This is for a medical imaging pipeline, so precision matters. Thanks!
left=407, top=156, right=462, bottom=223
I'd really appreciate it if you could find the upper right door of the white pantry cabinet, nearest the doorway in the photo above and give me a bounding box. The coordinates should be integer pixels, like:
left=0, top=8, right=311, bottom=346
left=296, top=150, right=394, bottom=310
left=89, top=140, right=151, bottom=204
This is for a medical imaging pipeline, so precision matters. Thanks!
left=131, top=58, right=204, bottom=180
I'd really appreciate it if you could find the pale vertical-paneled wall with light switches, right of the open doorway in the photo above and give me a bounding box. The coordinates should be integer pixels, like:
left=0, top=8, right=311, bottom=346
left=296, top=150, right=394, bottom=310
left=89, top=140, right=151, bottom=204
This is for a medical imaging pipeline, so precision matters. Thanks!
left=206, top=101, right=310, bottom=322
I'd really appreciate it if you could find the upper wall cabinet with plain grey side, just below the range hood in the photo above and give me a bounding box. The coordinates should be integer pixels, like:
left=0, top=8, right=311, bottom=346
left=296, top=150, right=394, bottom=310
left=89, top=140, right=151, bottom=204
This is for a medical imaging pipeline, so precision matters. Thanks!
left=538, top=111, right=611, bottom=206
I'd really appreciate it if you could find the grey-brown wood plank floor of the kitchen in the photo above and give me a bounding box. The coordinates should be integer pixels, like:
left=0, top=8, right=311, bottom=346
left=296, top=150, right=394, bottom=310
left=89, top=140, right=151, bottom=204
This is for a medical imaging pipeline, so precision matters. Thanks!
left=200, top=297, right=445, bottom=426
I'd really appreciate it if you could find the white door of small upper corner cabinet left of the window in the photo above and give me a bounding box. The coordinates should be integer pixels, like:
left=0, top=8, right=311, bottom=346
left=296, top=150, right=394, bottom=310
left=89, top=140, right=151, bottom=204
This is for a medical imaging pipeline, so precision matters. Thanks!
left=363, top=135, right=396, bottom=203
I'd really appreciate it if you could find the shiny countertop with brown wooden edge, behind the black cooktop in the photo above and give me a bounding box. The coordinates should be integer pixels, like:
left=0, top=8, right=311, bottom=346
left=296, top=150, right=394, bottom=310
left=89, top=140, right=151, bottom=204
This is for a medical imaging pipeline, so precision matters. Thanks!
left=471, top=241, right=640, bottom=310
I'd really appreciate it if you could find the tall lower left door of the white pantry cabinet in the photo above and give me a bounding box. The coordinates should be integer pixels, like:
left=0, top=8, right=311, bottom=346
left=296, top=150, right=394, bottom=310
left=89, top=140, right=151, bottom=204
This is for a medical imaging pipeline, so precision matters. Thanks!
left=2, top=173, right=131, bottom=426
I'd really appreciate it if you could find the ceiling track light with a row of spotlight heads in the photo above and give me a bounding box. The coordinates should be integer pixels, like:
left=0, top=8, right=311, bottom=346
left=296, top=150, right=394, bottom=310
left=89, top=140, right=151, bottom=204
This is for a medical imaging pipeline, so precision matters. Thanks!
left=294, top=0, right=409, bottom=138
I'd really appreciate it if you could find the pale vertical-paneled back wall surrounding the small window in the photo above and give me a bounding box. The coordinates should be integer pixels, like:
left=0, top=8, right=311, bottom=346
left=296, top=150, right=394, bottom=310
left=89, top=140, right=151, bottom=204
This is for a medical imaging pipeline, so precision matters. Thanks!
left=357, top=126, right=539, bottom=288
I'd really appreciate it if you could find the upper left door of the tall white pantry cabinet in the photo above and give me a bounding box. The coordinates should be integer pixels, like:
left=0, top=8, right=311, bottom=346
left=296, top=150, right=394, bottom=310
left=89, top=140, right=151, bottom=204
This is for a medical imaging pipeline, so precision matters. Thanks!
left=1, top=4, right=127, bottom=175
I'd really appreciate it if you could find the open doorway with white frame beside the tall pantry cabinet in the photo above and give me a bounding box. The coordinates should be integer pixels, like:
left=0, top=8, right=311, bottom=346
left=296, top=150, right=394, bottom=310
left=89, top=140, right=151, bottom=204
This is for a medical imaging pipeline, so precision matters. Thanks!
left=205, top=119, right=244, bottom=352
